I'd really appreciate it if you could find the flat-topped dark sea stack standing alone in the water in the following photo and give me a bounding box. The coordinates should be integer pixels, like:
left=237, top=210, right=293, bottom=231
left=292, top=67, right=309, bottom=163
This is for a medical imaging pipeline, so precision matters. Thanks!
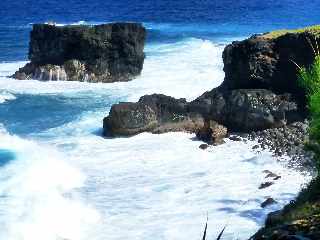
left=12, top=23, right=146, bottom=82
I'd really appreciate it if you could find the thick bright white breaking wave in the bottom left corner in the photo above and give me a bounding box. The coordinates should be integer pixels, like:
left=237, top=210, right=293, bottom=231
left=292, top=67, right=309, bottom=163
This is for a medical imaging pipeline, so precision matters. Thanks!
left=0, top=126, right=99, bottom=240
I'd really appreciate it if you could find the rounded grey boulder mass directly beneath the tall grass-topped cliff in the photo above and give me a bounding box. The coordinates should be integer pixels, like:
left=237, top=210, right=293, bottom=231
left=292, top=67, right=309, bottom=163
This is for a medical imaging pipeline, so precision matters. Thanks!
left=189, top=88, right=300, bottom=132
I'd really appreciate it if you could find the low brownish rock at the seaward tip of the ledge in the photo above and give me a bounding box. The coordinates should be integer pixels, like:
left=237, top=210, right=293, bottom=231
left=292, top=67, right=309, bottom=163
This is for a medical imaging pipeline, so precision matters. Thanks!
left=103, top=94, right=204, bottom=136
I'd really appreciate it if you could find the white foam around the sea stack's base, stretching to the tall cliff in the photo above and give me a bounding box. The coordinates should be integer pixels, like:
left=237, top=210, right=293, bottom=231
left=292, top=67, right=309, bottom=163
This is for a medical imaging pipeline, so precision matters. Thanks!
left=0, top=39, right=223, bottom=101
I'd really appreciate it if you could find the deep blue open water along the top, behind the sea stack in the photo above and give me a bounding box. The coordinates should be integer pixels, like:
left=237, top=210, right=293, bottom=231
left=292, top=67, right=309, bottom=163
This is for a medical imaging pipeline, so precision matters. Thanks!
left=0, top=0, right=320, bottom=61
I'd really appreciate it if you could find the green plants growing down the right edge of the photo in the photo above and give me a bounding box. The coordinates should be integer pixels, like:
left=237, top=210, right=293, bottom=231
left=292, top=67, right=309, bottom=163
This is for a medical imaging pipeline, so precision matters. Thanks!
left=262, top=36, right=320, bottom=233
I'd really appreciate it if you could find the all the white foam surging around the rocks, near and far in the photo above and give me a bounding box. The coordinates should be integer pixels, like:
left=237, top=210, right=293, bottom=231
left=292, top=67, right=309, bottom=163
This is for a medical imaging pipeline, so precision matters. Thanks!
left=0, top=39, right=310, bottom=240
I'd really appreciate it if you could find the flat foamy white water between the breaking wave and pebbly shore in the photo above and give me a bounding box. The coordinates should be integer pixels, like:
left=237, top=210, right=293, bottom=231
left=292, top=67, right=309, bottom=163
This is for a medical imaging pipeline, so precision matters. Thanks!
left=45, top=129, right=310, bottom=239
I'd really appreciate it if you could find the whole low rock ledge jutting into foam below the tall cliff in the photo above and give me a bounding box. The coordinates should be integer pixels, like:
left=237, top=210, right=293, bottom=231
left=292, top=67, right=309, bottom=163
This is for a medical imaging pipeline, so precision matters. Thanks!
left=104, top=88, right=298, bottom=137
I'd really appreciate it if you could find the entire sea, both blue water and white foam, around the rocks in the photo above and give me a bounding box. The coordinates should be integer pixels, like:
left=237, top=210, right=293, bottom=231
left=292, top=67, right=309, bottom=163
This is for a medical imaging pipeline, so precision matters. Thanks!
left=0, top=0, right=320, bottom=240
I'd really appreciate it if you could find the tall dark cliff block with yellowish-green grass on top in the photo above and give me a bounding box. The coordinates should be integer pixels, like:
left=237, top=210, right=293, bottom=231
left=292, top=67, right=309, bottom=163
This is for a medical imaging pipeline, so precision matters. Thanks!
left=223, top=31, right=317, bottom=105
